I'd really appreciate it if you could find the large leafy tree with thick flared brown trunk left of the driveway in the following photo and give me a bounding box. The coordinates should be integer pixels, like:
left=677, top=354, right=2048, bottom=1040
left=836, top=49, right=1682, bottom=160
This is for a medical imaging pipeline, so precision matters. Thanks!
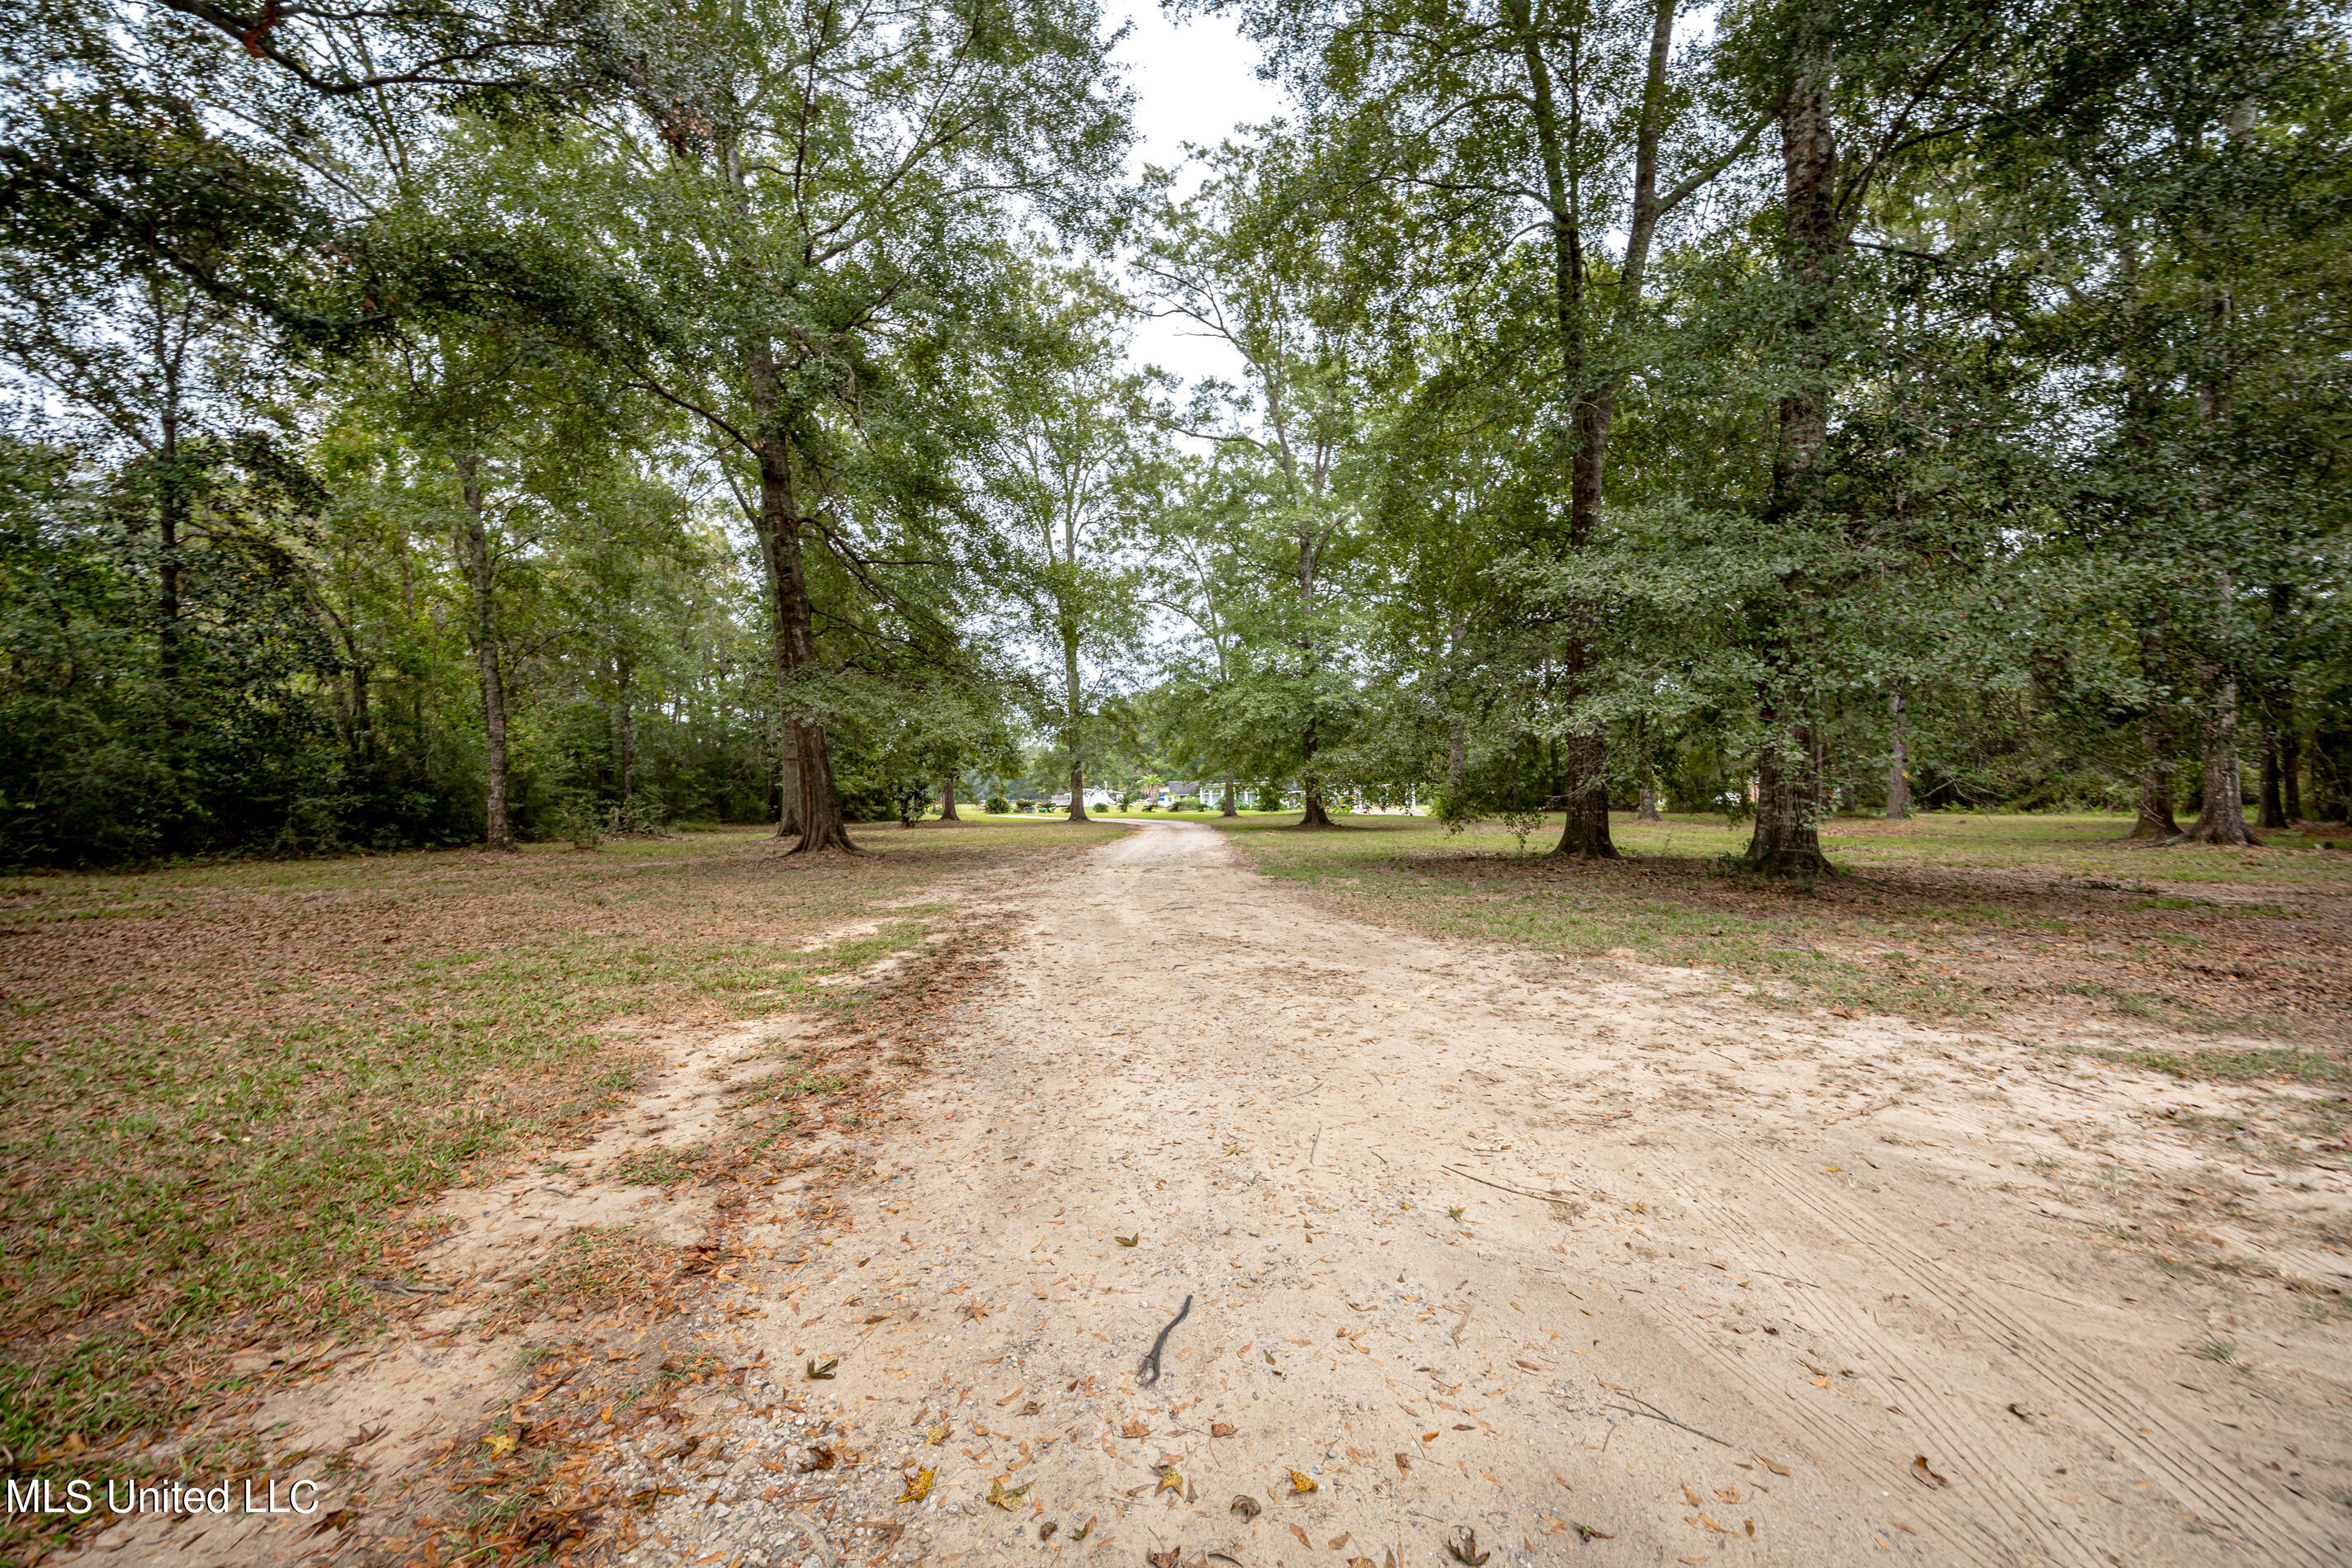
left=519, top=0, right=1126, bottom=851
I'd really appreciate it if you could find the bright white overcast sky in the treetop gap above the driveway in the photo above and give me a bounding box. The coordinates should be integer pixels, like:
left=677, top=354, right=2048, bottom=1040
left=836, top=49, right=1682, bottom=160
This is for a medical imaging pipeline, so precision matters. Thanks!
left=1106, top=0, right=1282, bottom=380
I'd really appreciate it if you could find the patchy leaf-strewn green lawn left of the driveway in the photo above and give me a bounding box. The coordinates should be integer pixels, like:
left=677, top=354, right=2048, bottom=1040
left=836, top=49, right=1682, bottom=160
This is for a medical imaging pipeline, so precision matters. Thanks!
left=0, top=823, right=1124, bottom=1485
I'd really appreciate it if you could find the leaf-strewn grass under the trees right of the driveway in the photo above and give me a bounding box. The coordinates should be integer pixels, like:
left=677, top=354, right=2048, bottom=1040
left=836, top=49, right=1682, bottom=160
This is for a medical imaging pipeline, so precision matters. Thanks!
left=1223, top=814, right=2352, bottom=1081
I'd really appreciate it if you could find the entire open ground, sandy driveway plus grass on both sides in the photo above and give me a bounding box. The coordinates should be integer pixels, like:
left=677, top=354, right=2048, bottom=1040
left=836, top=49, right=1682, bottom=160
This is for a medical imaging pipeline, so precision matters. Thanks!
left=7, top=818, right=2352, bottom=1568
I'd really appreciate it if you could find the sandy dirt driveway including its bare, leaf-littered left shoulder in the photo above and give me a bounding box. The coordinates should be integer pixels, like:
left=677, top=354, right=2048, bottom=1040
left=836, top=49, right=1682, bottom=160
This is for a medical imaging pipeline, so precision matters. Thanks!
left=68, top=823, right=2352, bottom=1568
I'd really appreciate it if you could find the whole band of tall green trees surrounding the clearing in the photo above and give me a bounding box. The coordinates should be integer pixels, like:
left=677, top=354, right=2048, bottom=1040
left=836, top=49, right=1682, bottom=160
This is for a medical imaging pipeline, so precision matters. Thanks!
left=0, top=0, right=2352, bottom=875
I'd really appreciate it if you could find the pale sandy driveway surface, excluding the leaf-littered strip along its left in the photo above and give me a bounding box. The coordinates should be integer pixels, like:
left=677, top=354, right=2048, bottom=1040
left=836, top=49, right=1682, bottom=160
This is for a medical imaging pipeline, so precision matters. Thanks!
left=633, top=825, right=2352, bottom=1568
